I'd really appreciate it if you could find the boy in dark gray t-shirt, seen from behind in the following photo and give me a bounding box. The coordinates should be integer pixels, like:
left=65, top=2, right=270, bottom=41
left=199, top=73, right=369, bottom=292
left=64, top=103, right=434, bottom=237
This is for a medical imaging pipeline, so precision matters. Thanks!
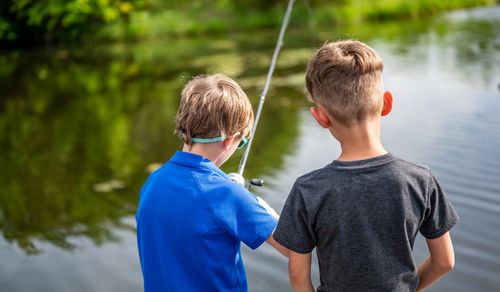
left=274, top=40, right=458, bottom=291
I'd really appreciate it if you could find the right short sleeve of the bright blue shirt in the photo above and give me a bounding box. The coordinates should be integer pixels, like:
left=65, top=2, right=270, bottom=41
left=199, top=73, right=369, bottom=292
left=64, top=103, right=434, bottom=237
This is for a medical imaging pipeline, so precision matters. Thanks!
left=199, top=182, right=277, bottom=249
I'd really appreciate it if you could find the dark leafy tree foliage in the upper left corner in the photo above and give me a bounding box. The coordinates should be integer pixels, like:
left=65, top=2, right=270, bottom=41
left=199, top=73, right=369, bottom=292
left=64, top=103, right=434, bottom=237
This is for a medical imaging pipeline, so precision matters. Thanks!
left=0, top=0, right=137, bottom=43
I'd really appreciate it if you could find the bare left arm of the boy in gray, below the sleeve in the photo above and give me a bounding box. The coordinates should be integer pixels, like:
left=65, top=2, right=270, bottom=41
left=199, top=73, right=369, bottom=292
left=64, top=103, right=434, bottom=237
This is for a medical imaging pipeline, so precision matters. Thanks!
left=288, top=251, right=314, bottom=292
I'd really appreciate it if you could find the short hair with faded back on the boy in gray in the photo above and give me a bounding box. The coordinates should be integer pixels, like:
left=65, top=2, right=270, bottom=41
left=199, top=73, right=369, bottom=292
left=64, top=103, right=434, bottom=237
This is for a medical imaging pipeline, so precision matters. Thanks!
left=306, top=40, right=384, bottom=127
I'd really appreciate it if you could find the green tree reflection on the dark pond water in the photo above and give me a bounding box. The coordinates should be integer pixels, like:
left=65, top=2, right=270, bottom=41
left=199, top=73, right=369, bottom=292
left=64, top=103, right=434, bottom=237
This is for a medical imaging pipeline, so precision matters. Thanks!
left=0, top=33, right=300, bottom=253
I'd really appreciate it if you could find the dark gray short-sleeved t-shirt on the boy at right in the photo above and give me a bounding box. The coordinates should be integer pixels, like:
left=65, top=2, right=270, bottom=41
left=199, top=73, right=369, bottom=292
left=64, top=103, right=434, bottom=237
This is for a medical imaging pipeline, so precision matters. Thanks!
left=274, top=154, right=458, bottom=291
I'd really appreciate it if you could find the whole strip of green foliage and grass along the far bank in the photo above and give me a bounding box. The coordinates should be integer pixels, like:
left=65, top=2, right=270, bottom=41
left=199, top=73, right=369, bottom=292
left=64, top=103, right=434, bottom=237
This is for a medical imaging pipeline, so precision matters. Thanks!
left=0, top=0, right=499, bottom=46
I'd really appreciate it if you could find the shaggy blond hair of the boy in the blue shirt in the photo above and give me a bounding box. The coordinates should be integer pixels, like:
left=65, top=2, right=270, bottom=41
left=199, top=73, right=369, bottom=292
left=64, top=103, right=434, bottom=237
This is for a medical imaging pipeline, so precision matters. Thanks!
left=175, top=74, right=254, bottom=145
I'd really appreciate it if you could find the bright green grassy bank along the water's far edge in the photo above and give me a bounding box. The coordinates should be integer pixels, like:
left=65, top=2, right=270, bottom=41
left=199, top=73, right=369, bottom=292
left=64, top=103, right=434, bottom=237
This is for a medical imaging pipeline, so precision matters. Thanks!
left=97, top=0, right=498, bottom=41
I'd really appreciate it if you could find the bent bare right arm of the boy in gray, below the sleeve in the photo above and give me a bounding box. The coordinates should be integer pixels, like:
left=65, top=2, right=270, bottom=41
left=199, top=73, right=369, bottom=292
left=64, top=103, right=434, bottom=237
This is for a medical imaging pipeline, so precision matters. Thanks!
left=417, top=232, right=455, bottom=291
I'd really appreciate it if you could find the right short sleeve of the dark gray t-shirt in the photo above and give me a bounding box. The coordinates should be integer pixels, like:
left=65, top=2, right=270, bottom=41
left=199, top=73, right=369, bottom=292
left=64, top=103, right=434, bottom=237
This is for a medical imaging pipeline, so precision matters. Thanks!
left=420, top=174, right=458, bottom=239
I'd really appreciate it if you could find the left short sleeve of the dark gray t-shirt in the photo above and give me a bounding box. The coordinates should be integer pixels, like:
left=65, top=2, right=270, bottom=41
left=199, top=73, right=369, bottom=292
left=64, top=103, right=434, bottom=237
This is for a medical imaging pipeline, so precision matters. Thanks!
left=273, top=183, right=316, bottom=253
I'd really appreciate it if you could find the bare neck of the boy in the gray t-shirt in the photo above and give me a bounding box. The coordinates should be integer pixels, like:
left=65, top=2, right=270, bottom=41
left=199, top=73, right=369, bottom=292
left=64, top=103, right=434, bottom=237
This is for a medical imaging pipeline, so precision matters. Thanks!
left=330, top=120, right=387, bottom=161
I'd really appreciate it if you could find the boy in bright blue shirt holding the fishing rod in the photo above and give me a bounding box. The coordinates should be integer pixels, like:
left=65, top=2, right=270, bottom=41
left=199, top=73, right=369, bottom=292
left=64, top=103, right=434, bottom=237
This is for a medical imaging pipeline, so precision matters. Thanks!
left=136, top=74, right=288, bottom=292
